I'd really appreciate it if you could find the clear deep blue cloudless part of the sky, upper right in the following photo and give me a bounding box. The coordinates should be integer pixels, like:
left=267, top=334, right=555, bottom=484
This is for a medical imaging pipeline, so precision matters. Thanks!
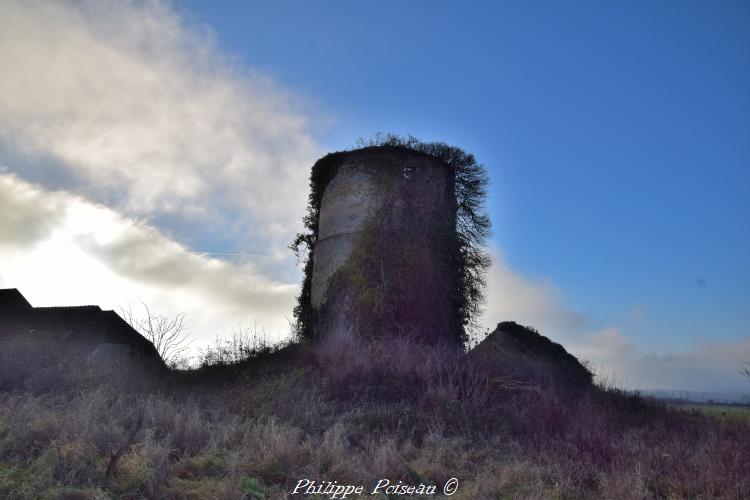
left=181, top=1, right=750, bottom=350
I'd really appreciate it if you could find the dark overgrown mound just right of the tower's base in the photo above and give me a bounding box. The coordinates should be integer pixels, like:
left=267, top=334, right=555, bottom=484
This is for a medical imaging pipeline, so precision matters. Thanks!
left=468, top=321, right=592, bottom=389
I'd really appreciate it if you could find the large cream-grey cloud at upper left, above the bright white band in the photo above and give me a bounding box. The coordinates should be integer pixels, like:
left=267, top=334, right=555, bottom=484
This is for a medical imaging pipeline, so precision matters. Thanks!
left=0, top=0, right=318, bottom=252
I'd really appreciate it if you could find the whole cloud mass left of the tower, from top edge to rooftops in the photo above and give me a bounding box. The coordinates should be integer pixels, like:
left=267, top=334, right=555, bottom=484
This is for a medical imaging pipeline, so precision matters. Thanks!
left=0, top=0, right=319, bottom=350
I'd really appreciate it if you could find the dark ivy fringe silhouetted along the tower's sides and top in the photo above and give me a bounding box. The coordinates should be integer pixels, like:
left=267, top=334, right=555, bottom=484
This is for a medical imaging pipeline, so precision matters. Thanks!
left=290, top=133, right=491, bottom=348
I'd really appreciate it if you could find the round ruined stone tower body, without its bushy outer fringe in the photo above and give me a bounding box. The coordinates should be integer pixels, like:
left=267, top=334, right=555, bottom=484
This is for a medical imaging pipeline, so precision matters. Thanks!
left=295, top=146, right=494, bottom=344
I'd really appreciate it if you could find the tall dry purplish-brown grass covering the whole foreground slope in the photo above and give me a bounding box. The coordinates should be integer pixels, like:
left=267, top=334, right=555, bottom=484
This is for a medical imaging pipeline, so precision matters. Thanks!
left=0, top=339, right=750, bottom=499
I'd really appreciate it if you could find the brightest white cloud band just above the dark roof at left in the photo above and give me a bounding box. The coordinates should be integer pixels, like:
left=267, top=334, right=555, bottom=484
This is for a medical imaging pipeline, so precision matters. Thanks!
left=0, top=174, right=298, bottom=344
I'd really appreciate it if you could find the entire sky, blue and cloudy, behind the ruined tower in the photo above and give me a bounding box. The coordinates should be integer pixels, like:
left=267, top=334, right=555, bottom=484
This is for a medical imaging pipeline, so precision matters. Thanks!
left=0, top=0, right=750, bottom=390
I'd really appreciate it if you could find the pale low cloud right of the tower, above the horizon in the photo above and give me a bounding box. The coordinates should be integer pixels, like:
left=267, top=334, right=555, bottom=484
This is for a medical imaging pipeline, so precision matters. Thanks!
left=483, top=250, right=750, bottom=391
